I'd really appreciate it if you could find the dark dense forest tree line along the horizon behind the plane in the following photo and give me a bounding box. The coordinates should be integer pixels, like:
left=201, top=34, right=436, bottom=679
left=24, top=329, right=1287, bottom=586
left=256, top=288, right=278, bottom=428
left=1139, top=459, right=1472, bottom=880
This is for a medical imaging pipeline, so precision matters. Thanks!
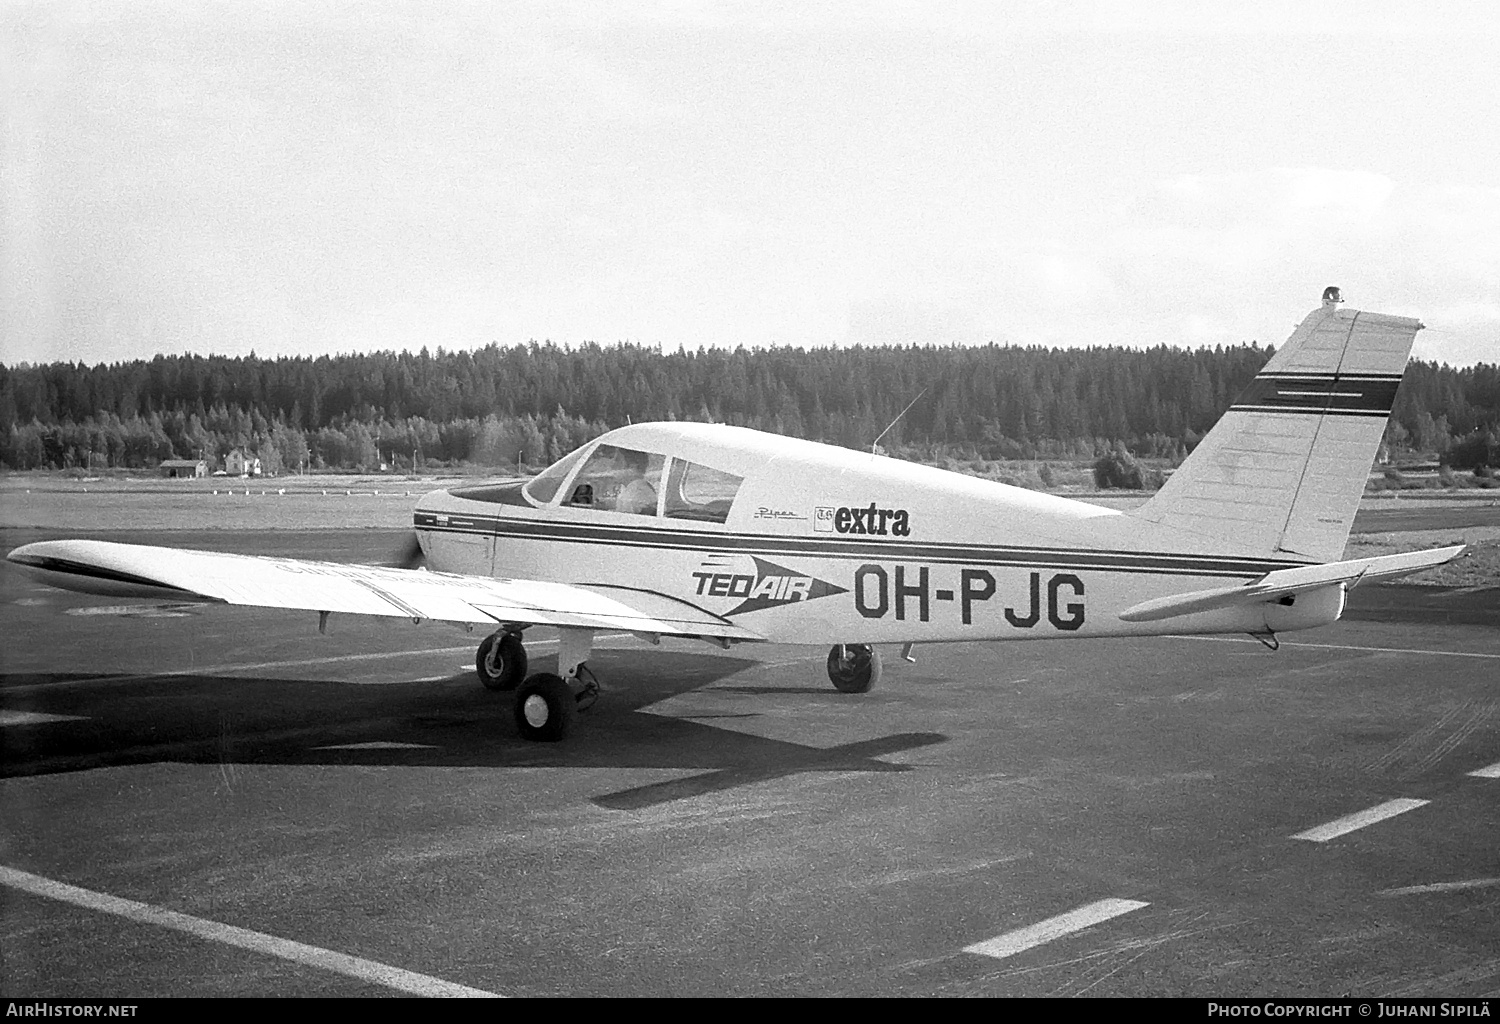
left=0, top=343, right=1500, bottom=472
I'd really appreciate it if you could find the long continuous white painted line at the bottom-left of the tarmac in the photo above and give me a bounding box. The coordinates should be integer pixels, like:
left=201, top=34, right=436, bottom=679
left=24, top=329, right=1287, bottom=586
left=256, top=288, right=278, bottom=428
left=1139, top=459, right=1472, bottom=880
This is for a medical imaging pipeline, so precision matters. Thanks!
left=0, top=867, right=498, bottom=999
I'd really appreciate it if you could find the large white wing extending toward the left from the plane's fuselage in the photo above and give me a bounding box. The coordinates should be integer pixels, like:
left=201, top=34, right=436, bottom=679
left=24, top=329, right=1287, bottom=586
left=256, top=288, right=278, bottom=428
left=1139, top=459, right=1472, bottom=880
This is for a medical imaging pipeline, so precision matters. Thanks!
left=6, top=540, right=764, bottom=640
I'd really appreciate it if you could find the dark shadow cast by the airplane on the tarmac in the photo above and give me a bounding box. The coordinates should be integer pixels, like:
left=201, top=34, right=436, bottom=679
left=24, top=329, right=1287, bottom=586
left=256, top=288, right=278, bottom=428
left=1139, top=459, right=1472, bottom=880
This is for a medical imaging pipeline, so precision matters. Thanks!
left=0, top=651, right=947, bottom=810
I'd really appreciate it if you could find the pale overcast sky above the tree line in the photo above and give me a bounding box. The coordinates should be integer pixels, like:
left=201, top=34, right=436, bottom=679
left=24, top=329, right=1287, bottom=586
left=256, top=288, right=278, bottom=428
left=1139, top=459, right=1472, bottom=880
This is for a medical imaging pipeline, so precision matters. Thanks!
left=0, top=0, right=1500, bottom=363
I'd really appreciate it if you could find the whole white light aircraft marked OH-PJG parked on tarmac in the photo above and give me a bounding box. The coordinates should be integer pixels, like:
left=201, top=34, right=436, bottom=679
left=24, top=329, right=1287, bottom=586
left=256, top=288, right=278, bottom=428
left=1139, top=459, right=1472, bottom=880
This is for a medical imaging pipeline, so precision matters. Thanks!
left=9, top=288, right=1463, bottom=741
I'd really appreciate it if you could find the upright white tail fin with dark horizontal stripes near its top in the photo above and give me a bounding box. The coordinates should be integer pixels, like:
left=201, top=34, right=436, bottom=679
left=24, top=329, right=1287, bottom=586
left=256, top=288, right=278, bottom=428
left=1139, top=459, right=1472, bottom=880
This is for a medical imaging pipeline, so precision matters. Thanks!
left=1134, top=288, right=1422, bottom=562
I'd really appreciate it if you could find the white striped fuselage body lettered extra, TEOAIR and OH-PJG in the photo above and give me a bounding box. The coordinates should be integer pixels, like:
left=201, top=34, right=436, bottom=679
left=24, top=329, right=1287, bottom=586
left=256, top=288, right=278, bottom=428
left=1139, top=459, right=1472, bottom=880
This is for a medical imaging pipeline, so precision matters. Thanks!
left=416, top=423, right=1344, bottom=643
